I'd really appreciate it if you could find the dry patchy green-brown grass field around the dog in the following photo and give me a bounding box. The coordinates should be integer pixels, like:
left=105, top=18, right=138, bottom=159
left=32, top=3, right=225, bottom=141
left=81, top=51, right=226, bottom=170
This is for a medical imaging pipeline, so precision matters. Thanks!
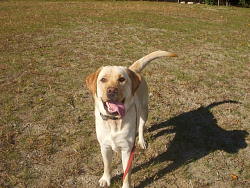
left=0, top=1, right=250, bottom=188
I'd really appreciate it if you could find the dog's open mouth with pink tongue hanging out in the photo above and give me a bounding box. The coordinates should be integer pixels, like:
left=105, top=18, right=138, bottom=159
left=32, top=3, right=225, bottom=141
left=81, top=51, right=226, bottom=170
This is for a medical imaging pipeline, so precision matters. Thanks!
left=102, top=98, right=125, bottom=117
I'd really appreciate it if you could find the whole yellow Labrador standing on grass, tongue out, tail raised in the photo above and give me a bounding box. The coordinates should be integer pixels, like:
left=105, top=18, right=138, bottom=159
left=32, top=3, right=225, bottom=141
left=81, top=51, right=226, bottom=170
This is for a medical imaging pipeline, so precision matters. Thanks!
left=86, top=51, right=176, bottom=188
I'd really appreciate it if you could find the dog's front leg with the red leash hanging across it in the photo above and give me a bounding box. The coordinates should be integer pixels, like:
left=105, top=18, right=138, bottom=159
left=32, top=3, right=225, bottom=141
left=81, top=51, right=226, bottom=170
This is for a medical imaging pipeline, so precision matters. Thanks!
left=122, top=150, right=132, bottom=188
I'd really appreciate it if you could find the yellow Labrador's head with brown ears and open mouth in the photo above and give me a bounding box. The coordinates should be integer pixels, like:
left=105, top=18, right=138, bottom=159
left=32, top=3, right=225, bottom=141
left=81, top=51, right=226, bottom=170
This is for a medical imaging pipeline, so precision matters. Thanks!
left=86, top=66, right=141, bottom=116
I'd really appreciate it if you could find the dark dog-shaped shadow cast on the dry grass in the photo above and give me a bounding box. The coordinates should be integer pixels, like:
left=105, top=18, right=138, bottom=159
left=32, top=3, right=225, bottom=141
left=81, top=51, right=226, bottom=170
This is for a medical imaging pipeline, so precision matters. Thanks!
left=115, top=100, right=248, bottom=188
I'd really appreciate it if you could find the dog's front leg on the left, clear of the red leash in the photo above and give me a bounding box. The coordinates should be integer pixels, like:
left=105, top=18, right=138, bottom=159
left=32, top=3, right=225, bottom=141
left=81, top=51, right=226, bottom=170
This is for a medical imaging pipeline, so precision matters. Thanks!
left=99, top=146, right=113, bottom=187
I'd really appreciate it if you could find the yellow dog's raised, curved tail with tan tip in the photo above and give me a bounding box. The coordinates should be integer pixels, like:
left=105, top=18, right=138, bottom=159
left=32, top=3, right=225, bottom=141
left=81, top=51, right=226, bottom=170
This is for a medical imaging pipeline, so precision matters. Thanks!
left=129, top=50, right=177, bottom=73
